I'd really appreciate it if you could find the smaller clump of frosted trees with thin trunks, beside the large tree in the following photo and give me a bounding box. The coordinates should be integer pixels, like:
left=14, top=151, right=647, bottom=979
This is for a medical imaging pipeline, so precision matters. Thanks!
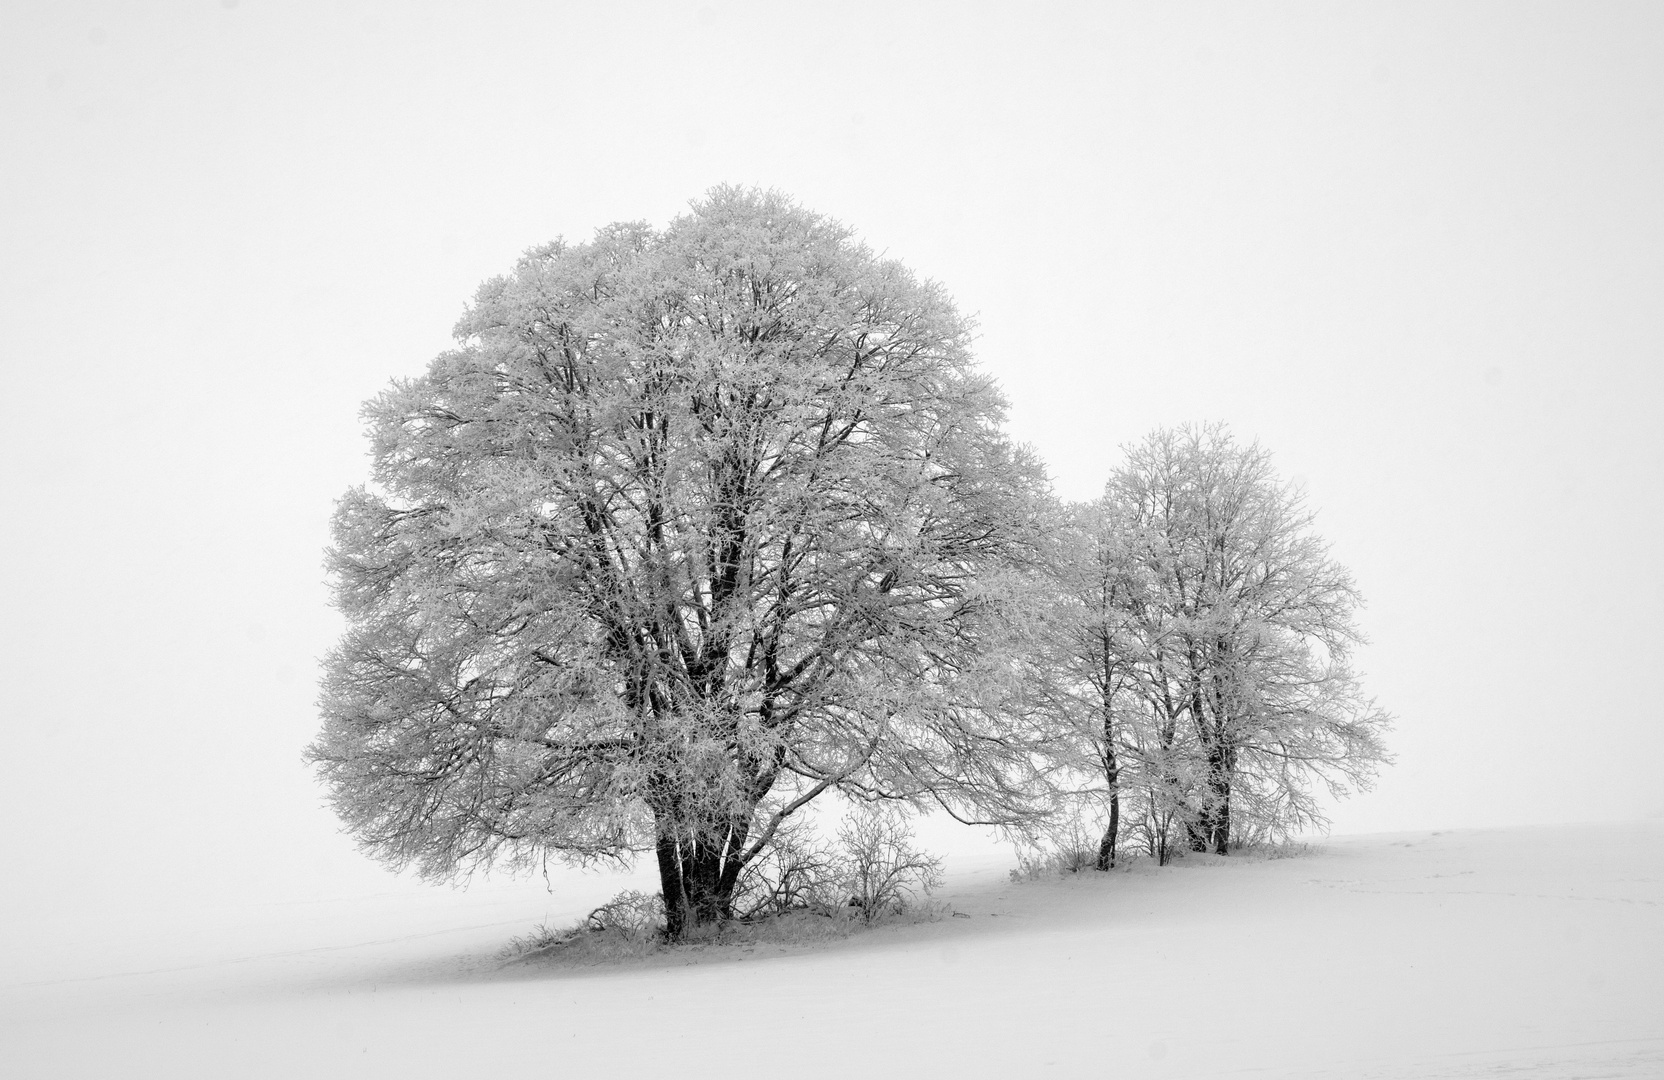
left=1048, top=424, right=1389, bottom=867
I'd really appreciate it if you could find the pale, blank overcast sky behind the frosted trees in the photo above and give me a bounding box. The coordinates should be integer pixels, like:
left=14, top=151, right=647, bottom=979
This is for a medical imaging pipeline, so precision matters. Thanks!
left=0, top=0, right=1664, bottom=910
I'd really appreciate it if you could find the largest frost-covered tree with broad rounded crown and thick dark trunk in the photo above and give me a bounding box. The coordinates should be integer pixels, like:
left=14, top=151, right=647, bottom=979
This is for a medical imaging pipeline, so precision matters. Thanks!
left=311, top=188, right=1045, bottom=937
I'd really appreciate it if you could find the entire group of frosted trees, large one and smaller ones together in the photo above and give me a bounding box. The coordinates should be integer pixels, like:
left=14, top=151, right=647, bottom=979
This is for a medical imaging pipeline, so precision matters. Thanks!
left=310, top=188, right=1386, bottom=939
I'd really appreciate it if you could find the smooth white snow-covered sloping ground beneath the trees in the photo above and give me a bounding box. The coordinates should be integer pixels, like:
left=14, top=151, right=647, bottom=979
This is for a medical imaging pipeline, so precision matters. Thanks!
left=0, top=822, right=1664, bottom=1078
